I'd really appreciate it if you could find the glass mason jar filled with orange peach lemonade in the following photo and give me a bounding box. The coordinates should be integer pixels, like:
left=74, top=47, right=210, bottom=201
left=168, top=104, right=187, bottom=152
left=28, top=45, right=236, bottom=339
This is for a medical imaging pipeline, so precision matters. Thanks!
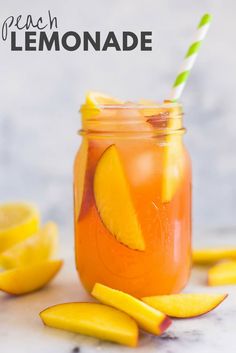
left=74, top=103, right=191, bottom=297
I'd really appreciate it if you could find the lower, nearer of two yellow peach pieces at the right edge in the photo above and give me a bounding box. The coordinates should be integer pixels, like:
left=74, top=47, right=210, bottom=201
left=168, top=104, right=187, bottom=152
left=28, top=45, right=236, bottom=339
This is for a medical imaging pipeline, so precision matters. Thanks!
left=208, top=261, right=236, bottom=286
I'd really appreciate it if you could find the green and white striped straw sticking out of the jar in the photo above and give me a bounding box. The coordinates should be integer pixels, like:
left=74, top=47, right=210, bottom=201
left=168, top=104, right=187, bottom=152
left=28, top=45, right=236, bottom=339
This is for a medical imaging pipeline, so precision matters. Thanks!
left=169, top=14, right=212, bottom=101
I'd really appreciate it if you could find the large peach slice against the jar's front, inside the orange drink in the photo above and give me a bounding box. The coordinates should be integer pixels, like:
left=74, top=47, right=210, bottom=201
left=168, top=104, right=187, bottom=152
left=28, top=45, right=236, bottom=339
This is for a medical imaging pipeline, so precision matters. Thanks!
left=94, top=145, right=145, bottom=250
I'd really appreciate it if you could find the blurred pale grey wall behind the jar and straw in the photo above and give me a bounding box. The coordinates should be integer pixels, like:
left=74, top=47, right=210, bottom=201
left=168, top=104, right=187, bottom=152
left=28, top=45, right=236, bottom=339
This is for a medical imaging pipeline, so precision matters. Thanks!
left=0, top=0, right=236, bottom=238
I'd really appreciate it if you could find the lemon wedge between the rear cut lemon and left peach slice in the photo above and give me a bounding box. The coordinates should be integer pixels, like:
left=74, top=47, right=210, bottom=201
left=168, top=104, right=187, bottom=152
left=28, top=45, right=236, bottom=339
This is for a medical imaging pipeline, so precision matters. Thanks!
left=0, top=222, right=58, bottom=269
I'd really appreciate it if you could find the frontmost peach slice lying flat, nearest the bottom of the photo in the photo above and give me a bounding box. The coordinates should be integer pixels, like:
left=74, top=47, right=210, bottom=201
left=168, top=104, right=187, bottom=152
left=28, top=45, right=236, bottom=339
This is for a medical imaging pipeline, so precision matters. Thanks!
left=39, top=303, right=138, bottom=347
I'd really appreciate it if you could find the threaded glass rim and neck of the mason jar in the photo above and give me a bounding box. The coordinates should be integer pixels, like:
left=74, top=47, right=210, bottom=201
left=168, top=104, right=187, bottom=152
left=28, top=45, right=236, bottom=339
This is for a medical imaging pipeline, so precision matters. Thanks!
left=80, top=101, right=184, bottom=136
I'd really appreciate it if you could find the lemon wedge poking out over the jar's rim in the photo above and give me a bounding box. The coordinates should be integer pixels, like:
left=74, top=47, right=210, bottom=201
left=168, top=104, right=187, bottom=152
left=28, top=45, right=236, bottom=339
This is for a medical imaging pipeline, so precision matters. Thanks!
left=81, top=91, right=123, bottom=119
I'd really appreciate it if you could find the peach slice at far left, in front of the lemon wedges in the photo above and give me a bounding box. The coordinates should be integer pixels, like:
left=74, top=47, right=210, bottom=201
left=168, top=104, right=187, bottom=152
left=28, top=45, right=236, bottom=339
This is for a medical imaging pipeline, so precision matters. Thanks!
left=0, top=260, right=62, bottom=295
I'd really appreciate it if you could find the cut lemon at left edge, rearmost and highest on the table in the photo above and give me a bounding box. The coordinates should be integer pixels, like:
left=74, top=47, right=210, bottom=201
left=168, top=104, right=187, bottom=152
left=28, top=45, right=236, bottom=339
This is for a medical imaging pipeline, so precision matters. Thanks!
left=0, top=203, right=40, bottom=253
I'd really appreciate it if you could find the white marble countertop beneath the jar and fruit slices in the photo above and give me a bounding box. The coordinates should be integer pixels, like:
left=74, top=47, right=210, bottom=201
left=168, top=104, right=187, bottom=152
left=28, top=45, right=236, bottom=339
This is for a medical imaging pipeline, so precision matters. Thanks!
left=0, top=230, right=236, bottom=353
